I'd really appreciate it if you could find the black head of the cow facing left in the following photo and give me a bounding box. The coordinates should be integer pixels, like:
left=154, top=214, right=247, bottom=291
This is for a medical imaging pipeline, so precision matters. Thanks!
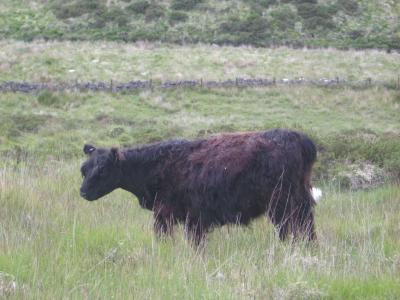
left=81, top=145, right=122, bottom=201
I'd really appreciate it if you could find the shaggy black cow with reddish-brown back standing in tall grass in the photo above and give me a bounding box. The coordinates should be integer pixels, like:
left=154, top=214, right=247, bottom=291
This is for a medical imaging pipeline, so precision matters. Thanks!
left=81, top=129, right=316, bottom=244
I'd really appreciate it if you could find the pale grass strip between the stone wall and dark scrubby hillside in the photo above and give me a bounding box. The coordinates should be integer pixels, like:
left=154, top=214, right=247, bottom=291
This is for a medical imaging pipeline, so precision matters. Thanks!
left=0, top=40, right=400, bottom=82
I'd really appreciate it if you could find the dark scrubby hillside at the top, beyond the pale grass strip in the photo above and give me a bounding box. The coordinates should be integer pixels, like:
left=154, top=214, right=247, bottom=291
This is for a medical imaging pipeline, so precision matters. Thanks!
left=0, top=0, right=400, bottom=50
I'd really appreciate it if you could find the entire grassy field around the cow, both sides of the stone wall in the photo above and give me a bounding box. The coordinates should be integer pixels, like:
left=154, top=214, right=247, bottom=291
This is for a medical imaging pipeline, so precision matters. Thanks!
left=0, top=41, right=400, bottom=299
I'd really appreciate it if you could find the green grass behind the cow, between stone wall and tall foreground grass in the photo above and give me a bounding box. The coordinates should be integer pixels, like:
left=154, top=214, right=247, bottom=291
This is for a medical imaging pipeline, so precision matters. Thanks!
left=0, top=87, right=400, bottom=185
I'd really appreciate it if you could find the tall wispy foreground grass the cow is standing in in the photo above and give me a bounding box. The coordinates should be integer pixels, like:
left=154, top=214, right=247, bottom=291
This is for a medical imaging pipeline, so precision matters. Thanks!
left=0, top=161, right=400, bottom=299
